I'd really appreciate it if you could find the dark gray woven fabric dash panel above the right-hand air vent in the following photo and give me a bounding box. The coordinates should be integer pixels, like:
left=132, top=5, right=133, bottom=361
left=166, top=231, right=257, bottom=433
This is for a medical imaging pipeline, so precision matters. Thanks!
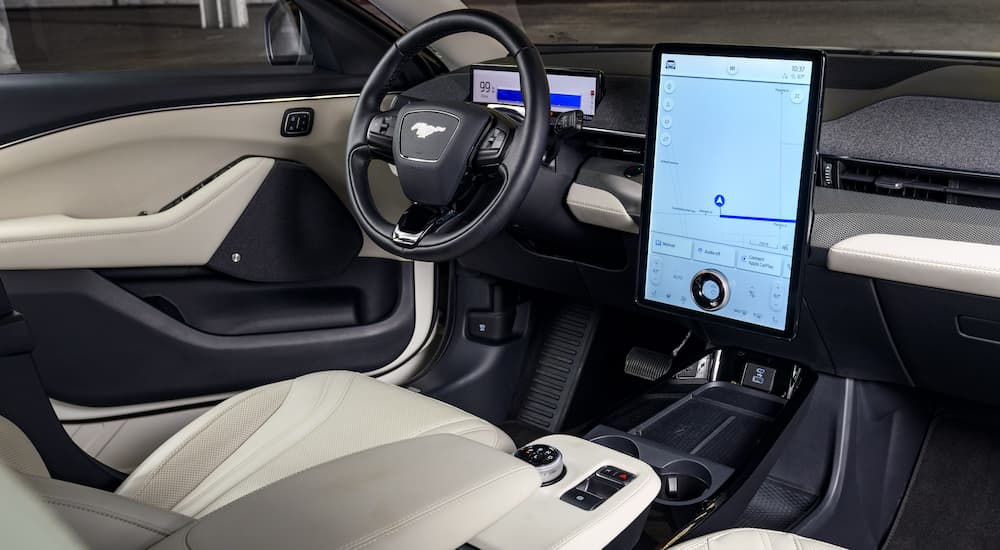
left=820, top=96, right=1000, bottom=174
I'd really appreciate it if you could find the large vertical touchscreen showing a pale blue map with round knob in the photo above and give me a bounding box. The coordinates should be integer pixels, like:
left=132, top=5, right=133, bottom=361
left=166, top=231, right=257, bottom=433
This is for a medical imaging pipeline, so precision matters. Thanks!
left=637, top=44, right=824, bottom=337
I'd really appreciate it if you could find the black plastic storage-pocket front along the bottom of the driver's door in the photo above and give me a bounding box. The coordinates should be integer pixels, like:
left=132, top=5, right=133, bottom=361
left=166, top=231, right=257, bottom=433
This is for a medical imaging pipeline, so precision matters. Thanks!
left=2, top=264, right=416, bottom=407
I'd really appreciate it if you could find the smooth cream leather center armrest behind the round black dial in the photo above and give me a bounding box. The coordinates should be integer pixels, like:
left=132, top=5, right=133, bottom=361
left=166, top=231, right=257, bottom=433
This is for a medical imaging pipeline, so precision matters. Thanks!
left=154, top=434, right=541, bottom=550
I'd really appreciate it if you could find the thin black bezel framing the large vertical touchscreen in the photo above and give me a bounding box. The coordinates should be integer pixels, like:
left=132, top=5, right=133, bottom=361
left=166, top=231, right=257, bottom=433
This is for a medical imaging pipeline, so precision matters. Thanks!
left=635, top=43, right=826, bottom=339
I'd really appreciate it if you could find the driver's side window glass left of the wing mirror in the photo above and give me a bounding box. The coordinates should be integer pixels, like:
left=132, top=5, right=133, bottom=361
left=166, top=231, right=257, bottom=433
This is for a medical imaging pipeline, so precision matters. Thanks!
left=0, top=0, right=271, bottom=73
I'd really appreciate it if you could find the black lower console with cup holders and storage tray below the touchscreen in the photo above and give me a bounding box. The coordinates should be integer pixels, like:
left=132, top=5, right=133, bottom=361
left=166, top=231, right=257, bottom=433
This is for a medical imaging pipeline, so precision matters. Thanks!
left=584, top=349, right=813, bottom=538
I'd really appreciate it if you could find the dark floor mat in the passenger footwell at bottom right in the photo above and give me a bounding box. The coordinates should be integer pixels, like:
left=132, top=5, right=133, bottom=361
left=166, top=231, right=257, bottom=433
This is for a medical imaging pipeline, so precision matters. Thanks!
left=883, top=418, right=1000, bottom=550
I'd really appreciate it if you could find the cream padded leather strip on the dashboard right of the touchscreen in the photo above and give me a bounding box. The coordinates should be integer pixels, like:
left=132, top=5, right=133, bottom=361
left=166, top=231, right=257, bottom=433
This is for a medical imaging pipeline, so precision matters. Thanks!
left=826, top=234, right=1000, bottom=298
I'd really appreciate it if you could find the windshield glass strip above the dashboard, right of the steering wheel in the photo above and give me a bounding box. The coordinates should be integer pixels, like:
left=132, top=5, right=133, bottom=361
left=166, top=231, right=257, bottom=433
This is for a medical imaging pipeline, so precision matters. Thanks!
left=466, top=0, right=1000, bottom=52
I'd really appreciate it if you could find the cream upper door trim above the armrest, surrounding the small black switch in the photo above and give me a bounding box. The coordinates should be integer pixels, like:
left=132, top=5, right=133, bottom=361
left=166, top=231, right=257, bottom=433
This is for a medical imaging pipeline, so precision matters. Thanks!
left=0, top=95, right=410, bottom=267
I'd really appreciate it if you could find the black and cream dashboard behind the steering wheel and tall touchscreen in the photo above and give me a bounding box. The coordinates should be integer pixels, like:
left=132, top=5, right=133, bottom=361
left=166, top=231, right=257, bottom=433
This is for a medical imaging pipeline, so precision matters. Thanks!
left=406, top=46, right=1000, bottom=403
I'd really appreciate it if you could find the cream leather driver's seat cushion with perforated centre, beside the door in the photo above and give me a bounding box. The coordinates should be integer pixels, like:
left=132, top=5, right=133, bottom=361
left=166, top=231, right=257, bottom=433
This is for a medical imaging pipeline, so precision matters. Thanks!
left=118, top=371, right=514, bottom=517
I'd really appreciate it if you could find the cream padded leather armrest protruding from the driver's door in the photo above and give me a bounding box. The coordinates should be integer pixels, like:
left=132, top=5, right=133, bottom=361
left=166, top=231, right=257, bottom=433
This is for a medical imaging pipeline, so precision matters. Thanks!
left=0, top=157, right=274, bottom=269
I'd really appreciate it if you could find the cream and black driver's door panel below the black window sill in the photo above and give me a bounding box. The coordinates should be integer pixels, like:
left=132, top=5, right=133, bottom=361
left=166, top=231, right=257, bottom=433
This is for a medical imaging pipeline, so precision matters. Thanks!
left=0, top=85, right=434, bottom=407
